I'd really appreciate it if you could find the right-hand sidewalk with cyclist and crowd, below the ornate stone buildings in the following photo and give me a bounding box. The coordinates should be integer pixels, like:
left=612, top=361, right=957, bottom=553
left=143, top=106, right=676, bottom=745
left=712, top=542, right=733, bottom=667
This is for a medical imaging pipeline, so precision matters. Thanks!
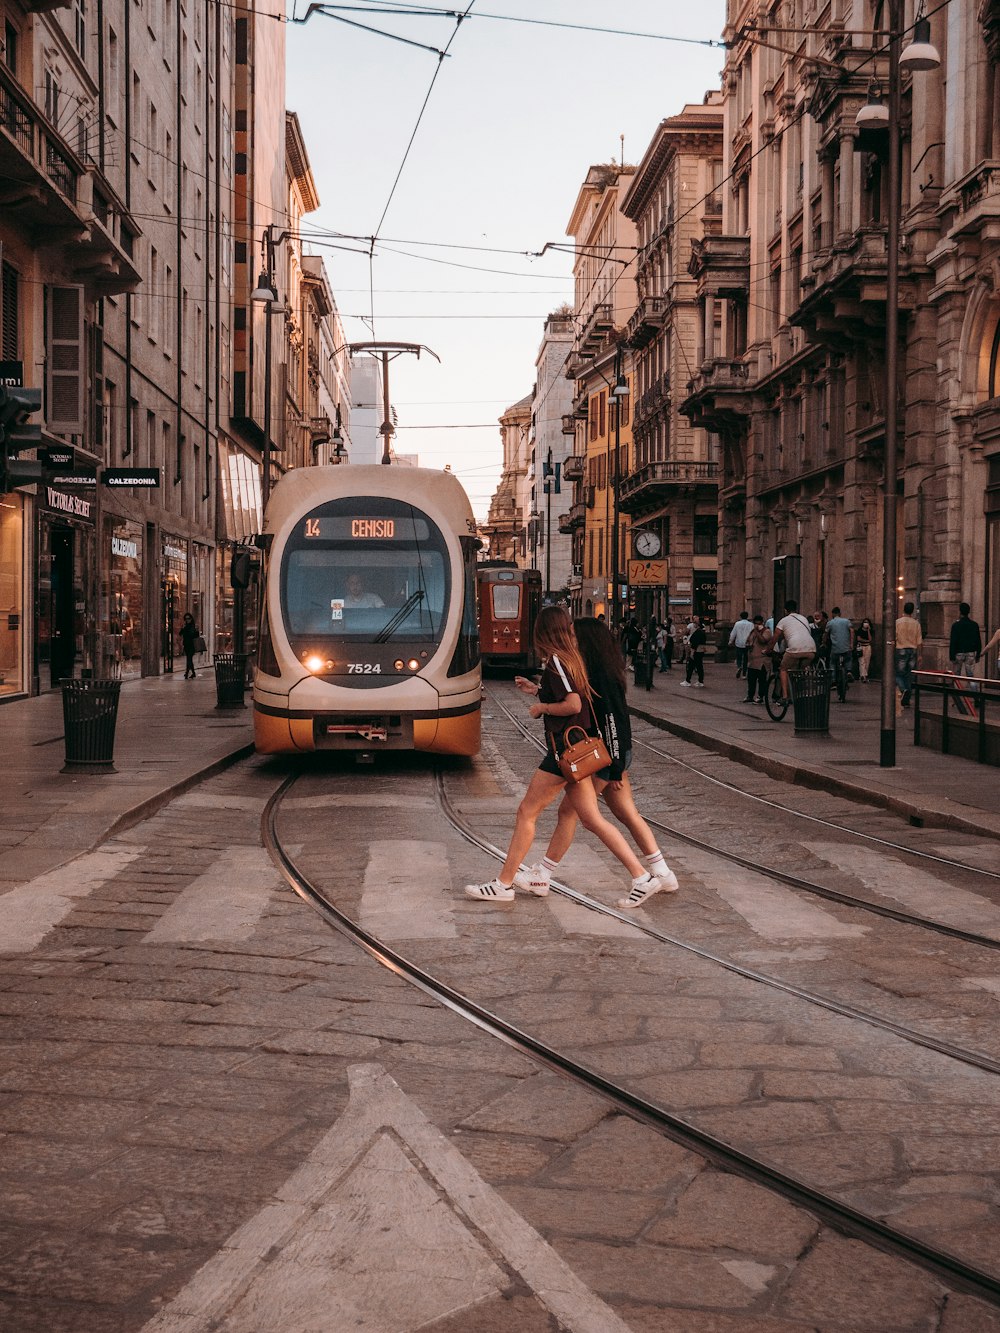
left=628, top=661, right=1000, bottom=837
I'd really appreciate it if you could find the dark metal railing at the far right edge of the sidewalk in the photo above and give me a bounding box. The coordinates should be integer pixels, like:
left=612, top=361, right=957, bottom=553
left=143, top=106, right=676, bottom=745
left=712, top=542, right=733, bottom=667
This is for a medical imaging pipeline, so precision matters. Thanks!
left=912, top=670, right=1000, bottom=764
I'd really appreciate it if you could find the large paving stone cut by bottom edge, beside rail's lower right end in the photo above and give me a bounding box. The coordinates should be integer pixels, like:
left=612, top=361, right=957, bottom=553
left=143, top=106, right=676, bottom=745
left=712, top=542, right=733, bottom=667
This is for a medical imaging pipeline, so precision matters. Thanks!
left=775, top=1232, right=943, bottom=1333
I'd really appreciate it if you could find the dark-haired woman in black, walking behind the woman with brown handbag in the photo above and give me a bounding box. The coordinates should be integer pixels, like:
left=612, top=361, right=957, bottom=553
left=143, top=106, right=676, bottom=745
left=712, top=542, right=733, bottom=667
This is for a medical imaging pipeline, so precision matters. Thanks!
left=513, top=619, right=677, bottom=908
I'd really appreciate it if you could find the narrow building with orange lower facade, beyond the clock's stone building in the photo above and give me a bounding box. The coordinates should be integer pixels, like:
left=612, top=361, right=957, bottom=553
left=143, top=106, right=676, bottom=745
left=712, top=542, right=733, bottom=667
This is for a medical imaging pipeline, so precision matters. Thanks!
left=560, top=163, right=636, bottom=624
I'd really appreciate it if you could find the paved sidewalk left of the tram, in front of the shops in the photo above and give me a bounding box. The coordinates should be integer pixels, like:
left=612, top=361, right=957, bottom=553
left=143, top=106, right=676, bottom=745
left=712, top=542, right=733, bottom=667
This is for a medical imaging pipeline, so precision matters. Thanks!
left=0, top=668, right=253, bottom=888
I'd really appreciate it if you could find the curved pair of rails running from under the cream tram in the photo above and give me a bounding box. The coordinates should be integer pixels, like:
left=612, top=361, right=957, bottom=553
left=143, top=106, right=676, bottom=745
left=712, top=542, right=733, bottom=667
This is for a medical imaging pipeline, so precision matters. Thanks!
left=261, top=772, right=1000, bottom=1306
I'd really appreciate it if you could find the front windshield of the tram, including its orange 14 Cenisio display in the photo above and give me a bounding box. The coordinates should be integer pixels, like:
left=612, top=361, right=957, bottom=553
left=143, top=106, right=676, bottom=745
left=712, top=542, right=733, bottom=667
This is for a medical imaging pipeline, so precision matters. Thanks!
left=281, top=497, right=451, bottom=644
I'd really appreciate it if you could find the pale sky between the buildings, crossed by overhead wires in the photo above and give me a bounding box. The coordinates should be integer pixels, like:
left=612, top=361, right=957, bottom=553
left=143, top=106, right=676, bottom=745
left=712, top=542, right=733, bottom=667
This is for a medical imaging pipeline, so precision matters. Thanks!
left=287, top=0, right=725, bottom=517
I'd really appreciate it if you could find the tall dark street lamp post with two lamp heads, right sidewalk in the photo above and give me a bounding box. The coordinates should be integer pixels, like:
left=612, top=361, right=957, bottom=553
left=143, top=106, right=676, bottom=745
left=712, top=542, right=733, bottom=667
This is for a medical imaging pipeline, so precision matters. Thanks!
left=856, top=0, right=941, bottom=768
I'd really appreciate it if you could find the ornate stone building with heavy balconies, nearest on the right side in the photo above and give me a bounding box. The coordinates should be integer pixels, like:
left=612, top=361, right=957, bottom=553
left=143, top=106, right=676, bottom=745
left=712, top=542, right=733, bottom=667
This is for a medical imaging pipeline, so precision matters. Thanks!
left=683, top=0, right=1000, bottom=665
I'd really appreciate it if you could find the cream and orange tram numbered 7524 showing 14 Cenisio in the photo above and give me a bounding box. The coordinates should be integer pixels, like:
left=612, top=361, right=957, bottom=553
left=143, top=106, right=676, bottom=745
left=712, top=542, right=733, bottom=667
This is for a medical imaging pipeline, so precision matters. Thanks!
left=253, top=464, right=481, bottom=754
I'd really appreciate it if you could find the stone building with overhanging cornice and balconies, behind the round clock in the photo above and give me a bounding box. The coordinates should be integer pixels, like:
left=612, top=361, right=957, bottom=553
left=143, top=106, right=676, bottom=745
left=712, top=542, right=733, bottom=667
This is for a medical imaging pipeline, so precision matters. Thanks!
left=620, top=93, right=723, bottom=623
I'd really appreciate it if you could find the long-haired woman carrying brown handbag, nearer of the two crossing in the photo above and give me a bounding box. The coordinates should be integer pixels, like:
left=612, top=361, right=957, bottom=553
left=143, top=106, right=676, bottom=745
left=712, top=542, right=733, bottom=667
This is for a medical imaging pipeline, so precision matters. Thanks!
left=465, top=607, right=669, bottom=902
